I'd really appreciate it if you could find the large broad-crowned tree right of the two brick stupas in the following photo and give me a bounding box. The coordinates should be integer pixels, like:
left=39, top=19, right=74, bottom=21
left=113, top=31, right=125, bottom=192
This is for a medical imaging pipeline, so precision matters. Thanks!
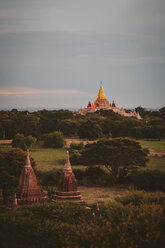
left=81, top=138, right=148, bottom=177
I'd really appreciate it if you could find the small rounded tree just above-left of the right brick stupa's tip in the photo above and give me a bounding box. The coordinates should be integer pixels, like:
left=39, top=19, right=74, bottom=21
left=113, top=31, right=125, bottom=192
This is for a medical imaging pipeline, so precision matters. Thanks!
left=44, top=131, right=66, bottom=148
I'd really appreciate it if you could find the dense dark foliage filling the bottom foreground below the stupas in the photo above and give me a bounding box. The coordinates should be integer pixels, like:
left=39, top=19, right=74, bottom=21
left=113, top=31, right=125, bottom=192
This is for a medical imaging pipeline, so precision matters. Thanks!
left=0, top=196, right=165, bottom=248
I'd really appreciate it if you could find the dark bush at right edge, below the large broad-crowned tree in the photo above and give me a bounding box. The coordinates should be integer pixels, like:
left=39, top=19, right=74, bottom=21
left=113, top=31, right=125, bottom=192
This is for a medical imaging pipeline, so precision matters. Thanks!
left=125, top=170, right=165, bottom=191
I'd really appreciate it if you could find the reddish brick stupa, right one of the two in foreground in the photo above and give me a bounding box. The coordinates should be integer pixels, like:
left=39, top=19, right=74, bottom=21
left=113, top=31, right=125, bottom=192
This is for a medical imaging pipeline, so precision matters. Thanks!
left=54, top=151, right=82, bottom=202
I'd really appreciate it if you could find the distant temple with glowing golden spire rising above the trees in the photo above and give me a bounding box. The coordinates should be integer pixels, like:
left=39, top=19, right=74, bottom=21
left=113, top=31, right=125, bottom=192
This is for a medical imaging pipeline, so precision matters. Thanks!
left=78, top=81, right=141, bottom=120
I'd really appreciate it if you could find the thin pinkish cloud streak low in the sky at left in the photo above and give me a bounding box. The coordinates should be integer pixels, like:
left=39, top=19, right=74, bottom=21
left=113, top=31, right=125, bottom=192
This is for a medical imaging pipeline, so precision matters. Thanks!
left=0, top=87, right=85, bottom=96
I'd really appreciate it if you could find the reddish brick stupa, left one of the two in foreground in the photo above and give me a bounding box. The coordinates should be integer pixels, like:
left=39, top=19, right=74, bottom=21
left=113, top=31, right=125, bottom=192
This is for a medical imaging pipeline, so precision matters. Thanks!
left=16, top=151, right=47, bottom=205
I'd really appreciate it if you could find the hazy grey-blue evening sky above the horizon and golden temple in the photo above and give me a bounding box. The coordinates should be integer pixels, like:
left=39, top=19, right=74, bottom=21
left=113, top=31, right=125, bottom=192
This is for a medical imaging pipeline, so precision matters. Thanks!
left=0, top=0, right=165, bottom=109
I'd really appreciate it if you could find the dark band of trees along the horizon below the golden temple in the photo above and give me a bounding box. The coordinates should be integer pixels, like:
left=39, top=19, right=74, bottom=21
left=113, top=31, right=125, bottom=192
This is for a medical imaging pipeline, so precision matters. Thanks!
left=0, top=107, right=165, bottom=140
